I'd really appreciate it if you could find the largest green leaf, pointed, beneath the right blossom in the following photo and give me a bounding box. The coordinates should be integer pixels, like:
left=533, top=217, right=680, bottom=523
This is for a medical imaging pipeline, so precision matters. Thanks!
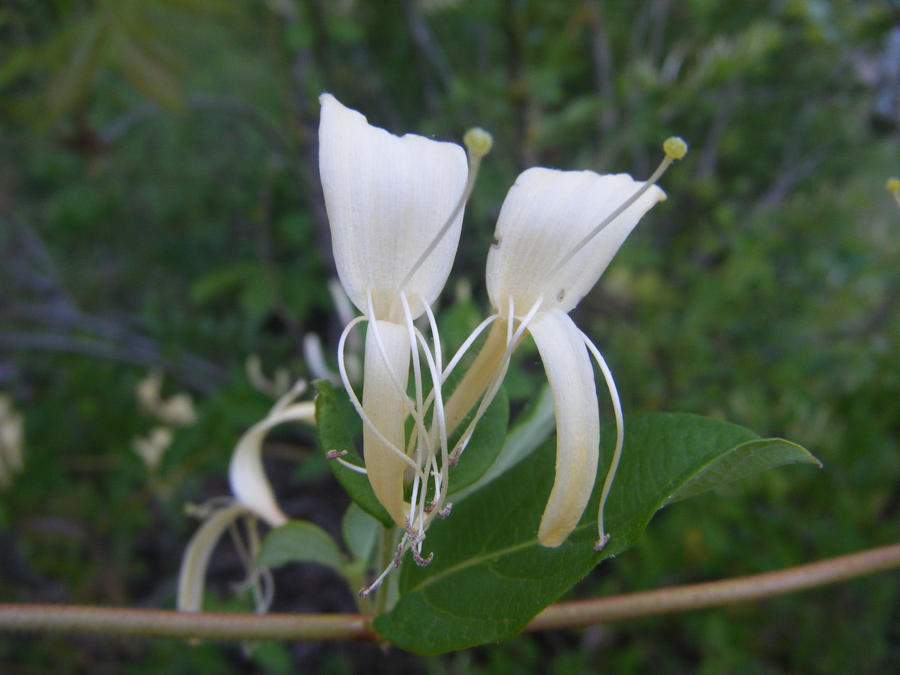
left=374, top=413, right=815, bottom=654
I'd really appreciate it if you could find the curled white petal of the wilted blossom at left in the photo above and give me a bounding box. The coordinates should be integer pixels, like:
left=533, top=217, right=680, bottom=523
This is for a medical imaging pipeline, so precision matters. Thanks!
left=228, top=401, right=316, bottom=527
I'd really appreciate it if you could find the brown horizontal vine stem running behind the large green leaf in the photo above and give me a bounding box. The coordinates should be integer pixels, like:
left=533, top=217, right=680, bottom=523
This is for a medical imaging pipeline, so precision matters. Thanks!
left=0, top=544, right=900, bottom=641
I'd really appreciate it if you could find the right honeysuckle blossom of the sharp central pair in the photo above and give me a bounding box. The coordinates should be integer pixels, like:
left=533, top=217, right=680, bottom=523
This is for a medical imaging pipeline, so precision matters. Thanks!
left=446, top=139, right=686, bottom=549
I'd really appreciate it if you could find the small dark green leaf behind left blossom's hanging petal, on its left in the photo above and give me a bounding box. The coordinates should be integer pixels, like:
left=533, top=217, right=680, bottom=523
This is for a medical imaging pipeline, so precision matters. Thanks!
left=315, top=380, right=394, bottom=527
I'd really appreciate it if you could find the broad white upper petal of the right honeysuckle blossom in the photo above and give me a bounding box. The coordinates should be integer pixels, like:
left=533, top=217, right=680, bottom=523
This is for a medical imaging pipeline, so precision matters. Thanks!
left=487, top=168, right=665, bottom=312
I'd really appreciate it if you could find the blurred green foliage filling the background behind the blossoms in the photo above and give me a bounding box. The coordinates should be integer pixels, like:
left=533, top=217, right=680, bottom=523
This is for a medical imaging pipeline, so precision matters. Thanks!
left=0, top=0, right=900, bottom=673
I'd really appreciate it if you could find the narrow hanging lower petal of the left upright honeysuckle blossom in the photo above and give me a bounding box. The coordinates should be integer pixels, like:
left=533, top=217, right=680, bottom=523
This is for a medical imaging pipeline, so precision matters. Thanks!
left=362, top=321, right=410, bottom=527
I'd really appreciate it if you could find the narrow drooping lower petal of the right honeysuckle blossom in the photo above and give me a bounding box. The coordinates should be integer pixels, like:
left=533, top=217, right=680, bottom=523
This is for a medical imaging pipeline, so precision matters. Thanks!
left=528, top=310, right=600, bottom=546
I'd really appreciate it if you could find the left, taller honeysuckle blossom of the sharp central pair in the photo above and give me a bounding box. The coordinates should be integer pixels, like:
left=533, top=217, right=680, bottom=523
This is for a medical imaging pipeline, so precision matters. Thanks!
left=319, top=94, right=489, bottom=580
